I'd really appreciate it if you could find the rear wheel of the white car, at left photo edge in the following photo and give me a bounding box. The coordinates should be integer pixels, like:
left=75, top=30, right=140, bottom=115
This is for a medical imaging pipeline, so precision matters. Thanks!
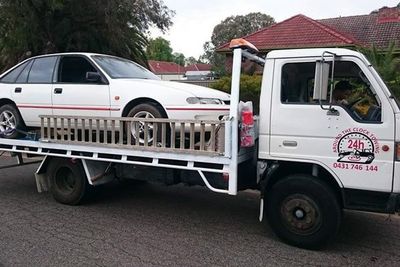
left=0, top=104, right=25, bottom=139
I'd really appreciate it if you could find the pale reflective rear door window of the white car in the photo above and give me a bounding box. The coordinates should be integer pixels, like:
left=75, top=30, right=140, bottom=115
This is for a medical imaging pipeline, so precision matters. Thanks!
left=28, top=57, right=57, bottom=83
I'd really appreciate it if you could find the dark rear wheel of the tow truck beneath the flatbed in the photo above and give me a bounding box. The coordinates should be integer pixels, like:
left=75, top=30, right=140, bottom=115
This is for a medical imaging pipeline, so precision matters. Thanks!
left=47, top=158, right=90, bottom=205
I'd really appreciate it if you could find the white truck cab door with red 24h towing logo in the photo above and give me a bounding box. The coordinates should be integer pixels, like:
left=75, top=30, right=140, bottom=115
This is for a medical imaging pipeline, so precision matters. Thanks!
left=270, top=57, right=395, bottom=192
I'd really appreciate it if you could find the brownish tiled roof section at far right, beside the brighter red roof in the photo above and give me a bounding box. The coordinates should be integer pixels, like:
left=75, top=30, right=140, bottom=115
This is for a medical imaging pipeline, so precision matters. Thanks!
left=318, top=7, right=400, bottom=48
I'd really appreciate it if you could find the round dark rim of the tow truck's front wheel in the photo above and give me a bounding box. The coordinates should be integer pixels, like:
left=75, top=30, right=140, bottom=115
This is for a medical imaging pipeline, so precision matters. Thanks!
left=281, top=194, right=321, bottom=235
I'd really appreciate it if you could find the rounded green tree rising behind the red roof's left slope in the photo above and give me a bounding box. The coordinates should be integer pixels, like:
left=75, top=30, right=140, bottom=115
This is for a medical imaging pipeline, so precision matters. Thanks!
left=201, top=12, right=275, bottom=75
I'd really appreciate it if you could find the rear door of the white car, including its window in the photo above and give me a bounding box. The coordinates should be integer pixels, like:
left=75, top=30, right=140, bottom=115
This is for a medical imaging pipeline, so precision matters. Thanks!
left=11, top=56, right=57, bottom=127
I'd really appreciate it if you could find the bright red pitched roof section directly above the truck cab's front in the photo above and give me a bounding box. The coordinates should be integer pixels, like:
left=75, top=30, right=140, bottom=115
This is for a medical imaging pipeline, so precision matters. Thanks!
left=217, top=14, right=358, bottom=52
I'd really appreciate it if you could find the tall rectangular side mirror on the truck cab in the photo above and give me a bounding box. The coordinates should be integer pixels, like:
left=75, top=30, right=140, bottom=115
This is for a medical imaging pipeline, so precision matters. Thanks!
left=313, top=60, right=330, bottom=100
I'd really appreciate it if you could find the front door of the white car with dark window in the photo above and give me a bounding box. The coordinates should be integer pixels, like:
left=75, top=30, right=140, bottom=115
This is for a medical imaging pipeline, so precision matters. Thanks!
left=52, top=55, right=110, bottom=117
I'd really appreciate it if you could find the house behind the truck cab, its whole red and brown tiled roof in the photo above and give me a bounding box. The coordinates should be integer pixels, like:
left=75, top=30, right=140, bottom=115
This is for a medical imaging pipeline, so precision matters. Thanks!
left=217, top=6, right=400, bottom=69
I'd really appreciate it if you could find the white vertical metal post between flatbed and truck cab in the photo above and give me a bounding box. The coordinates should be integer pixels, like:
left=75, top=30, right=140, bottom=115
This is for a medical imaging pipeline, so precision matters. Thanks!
left=225, top=48, right=242, bottom=195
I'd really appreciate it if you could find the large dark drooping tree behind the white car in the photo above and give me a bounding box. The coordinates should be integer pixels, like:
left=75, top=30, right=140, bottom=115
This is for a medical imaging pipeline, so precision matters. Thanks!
left=0, top=0, right=173, bottom=68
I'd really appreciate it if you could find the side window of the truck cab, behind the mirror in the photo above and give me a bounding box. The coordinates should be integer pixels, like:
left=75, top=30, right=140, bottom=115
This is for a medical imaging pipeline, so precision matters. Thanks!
left=281, top=61, right=381, bottom=123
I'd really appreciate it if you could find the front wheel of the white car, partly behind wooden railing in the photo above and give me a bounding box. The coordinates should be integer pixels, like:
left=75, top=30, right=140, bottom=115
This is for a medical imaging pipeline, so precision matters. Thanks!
left=127, top=103, right=165, bottom=145
